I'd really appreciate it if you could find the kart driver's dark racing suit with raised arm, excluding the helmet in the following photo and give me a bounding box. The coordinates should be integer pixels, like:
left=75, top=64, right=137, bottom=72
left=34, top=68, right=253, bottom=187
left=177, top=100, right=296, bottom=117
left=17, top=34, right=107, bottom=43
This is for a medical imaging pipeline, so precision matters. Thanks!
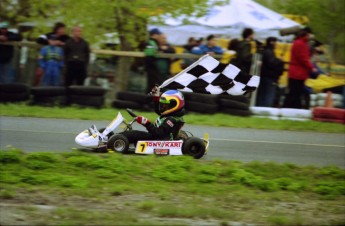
left=121, top=101, right=185, bottom=144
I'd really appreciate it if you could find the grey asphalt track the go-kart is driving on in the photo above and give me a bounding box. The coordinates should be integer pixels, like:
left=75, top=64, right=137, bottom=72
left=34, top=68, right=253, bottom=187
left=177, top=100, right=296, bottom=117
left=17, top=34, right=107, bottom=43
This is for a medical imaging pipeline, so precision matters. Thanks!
left=0, top=117, right=345, bottom=168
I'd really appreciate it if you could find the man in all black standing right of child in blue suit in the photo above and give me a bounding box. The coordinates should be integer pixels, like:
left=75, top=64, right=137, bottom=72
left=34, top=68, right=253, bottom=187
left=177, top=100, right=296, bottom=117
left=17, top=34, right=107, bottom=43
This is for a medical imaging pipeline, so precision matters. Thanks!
left=65, top=27, right=90, bottom=86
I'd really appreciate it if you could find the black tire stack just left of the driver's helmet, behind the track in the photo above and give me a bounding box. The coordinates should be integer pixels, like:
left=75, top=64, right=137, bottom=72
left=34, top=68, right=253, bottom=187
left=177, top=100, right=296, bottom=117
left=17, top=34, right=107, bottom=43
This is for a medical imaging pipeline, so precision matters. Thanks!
left=112, top=91, right=152, bottom=109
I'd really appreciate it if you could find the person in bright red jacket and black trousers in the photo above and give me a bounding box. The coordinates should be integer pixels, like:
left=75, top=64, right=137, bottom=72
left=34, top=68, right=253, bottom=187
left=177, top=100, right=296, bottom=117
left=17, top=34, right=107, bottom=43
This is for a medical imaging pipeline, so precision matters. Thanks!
left=284, top=29, right=316, bottom=108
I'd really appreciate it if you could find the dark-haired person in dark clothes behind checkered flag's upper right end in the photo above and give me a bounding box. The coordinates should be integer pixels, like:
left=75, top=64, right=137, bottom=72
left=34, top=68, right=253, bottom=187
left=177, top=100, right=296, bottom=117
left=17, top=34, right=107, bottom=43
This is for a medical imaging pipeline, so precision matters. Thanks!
left=231, top=28, right=254, bottom=74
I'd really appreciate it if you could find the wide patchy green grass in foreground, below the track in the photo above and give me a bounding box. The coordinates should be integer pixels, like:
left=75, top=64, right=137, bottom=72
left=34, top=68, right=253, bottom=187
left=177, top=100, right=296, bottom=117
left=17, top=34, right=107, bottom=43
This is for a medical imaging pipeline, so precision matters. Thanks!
left=0, top=150, right=345, bottom=225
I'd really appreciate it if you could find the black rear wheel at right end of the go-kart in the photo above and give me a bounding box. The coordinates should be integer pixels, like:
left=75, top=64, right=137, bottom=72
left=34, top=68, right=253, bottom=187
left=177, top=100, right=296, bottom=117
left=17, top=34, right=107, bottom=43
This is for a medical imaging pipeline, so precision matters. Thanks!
left=182, top=137, right=206, bottom=159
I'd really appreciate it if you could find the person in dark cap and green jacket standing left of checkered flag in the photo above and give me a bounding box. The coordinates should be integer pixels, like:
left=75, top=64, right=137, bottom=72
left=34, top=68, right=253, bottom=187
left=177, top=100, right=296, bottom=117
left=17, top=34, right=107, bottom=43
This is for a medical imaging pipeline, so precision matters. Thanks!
left=144, top=28, right=163, bottom=93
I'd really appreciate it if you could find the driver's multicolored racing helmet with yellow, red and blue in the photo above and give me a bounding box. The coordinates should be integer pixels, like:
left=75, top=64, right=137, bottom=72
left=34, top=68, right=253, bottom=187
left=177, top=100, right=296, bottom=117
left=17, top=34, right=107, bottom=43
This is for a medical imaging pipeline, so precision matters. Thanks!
left=159, top=90, right=184, bottom=115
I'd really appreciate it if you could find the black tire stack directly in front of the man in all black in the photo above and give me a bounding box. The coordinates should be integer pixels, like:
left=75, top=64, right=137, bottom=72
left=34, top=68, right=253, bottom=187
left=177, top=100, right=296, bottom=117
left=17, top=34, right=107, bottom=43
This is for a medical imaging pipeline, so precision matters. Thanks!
left=67, top=86, right=107, bottom=108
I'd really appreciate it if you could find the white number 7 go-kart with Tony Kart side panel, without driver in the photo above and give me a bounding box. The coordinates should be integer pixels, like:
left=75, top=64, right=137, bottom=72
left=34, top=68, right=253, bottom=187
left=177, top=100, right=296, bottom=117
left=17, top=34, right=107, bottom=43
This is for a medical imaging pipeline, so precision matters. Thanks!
left=75, top=109, right=209, bottom=159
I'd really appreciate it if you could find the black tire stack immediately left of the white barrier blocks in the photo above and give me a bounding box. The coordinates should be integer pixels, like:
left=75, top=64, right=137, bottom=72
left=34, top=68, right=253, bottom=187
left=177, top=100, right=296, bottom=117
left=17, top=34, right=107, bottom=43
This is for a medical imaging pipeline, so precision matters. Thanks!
left=219, top=95, right=251, bottom=116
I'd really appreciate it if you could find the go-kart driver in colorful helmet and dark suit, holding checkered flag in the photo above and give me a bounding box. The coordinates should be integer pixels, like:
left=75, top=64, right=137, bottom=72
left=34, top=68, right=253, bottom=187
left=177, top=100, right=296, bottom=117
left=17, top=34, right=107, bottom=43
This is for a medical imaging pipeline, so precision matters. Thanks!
left=121, top=87, right=185, bottom=144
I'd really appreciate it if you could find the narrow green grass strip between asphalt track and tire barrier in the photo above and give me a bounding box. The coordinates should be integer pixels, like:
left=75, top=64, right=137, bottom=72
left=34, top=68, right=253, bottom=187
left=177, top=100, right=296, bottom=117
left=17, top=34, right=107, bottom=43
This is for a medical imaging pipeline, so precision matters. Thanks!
left=0, top=104, right=345, bottom=133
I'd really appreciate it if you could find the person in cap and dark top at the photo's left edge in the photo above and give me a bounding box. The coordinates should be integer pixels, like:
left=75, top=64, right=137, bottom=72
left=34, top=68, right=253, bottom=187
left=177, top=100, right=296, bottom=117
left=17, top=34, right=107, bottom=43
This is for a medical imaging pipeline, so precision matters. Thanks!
left=0, top=21, right=22, bottom=83
